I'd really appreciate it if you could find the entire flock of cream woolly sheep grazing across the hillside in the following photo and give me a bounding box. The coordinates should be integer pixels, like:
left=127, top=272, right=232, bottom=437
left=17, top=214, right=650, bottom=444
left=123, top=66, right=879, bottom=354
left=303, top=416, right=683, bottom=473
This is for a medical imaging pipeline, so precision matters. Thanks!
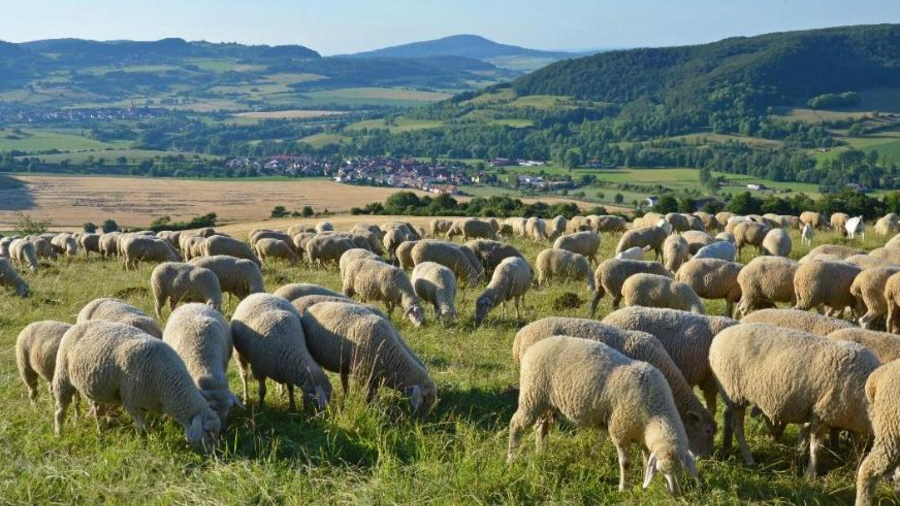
left=0, top=208, right=900, bottom=505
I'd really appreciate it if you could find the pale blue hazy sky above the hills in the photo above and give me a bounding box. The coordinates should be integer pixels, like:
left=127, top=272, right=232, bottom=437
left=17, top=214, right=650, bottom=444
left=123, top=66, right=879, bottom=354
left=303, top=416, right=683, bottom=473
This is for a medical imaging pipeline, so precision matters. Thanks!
left=0, top=0, right=900, bottom=54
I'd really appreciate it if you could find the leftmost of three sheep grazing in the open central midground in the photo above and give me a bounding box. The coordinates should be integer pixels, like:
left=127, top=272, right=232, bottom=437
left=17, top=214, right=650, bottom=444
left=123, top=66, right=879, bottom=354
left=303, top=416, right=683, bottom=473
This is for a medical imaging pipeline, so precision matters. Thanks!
left=341, top=259, right=425, bottom=327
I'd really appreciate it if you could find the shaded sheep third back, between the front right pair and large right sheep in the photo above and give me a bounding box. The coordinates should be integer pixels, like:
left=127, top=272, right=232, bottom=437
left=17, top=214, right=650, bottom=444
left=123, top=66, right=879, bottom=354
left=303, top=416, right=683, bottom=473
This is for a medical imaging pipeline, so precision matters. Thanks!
left=603, top=306, right=738, bottom=415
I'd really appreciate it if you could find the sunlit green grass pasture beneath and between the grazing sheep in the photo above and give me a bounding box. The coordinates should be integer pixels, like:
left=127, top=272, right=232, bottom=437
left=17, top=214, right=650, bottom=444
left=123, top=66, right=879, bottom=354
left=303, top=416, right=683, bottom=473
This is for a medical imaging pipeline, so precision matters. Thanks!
left=0, top=224, right=896, bottom=506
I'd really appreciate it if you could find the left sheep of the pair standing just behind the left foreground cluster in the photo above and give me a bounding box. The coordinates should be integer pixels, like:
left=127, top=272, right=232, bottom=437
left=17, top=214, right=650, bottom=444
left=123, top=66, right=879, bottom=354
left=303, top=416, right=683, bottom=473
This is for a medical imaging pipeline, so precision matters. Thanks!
left=150, top=262, right=222, bottom=318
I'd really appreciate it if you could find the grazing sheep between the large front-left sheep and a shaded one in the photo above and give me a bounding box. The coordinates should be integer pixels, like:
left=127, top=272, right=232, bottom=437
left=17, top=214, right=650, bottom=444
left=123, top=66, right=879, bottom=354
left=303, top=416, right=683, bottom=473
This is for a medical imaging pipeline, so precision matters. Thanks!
left=163, top=304, right=243, bottom=426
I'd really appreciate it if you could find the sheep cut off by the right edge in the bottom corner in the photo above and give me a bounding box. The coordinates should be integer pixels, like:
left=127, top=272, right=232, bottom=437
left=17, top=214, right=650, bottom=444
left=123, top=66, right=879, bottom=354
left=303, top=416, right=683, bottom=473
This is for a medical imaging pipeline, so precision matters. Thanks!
left=856, top=362, right=900, bottom=506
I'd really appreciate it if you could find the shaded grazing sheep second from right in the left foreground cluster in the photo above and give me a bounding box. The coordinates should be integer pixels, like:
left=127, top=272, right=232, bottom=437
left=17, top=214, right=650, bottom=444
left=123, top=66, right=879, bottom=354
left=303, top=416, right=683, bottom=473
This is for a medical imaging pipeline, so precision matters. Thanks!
left=231, top=293, right=331, bottom=411
